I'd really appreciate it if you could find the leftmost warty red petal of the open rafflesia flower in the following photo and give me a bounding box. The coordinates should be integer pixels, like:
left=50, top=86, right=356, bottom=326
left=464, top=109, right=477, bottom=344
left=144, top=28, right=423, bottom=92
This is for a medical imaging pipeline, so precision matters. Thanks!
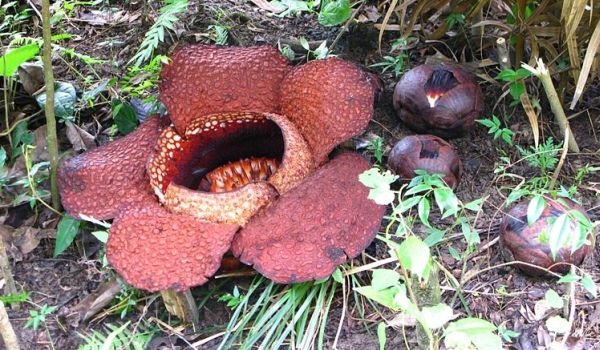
left=58, top=117, right=163, bottom=220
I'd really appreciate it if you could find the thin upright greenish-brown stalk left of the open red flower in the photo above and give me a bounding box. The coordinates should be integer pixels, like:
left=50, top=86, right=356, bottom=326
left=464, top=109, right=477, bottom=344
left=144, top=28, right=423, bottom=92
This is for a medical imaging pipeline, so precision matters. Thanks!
left=42, top=0, right=60, bottom=210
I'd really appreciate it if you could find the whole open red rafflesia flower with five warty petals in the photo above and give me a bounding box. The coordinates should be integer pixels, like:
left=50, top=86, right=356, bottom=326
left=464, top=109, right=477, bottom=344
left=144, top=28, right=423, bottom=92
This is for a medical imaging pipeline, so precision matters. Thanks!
left=59, top=46, right=384, bottom=291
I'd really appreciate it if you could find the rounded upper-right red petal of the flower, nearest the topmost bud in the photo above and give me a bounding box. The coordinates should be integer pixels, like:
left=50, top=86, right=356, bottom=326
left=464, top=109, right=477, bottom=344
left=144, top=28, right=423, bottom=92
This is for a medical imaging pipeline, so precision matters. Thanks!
left=281, top=58, right=375, bottom=164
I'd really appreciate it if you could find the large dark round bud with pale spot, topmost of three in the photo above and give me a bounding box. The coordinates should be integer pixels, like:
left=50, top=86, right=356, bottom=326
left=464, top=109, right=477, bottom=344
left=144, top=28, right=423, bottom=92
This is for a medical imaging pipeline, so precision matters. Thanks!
left=394, top=64, right=483, bottom=137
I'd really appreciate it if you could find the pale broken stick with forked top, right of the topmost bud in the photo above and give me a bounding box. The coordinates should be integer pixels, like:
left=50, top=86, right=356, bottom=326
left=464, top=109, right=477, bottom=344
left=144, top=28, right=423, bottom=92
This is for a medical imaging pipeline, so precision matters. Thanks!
left=521, top=58, right=579, bottom=153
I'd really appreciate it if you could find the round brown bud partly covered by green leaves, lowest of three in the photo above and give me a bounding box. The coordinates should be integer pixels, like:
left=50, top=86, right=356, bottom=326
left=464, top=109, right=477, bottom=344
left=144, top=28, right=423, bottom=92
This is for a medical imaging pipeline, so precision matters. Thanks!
left=500, top=198, right=593, bottom=276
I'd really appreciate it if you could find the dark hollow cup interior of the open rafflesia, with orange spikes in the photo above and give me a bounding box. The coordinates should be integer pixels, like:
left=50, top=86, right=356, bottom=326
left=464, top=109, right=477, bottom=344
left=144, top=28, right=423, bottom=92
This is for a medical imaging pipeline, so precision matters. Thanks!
left=149, top=113, right=284, bottom=193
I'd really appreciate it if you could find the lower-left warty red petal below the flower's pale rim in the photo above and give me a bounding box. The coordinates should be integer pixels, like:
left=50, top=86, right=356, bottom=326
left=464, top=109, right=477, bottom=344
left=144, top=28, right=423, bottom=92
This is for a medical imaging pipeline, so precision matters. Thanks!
left=106, top=204, right=238, bottom=292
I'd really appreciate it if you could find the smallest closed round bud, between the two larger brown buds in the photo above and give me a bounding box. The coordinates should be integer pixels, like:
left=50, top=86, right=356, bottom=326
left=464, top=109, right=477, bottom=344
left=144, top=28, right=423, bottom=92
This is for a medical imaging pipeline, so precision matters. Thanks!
left=388, top=135, right=462, bottom=189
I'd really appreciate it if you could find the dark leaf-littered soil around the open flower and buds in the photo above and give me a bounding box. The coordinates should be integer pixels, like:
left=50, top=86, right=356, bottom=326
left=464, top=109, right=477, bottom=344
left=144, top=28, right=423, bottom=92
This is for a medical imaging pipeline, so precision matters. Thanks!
left=0, top=0, right=600, bottom=350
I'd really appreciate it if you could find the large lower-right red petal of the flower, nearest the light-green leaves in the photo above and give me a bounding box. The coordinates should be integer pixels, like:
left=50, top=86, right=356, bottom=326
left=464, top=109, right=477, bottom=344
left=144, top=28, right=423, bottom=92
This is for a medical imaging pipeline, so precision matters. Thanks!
left=232, top=153, right=385, bottom=283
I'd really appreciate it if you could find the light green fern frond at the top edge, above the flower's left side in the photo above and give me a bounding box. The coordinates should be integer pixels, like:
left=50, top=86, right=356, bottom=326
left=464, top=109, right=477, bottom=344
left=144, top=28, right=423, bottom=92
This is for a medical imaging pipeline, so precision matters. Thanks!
left=128, top=0, right=188, bottom=67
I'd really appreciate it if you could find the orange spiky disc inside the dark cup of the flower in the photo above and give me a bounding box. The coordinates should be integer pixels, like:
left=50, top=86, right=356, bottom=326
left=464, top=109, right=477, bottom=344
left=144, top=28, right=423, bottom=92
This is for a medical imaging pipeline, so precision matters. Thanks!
left=200, top=157, right=279, bottom=192
